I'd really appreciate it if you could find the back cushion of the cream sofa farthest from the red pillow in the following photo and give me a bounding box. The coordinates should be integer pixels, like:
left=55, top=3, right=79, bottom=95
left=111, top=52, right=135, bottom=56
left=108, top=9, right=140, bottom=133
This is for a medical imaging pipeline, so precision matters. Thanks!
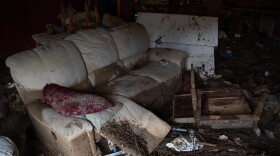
left=111, top=23, right=149, bottom=72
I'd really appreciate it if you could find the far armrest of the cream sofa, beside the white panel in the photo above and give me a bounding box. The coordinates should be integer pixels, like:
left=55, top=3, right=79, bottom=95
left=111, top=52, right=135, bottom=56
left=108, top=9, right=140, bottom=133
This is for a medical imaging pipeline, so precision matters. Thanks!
left=148, top=48, right=187, bottom=69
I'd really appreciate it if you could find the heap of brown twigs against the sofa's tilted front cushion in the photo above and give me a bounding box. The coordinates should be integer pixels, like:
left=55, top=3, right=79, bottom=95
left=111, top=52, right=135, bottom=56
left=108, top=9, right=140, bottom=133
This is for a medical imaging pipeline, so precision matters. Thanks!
left=101, top=120, right=149, bottom=156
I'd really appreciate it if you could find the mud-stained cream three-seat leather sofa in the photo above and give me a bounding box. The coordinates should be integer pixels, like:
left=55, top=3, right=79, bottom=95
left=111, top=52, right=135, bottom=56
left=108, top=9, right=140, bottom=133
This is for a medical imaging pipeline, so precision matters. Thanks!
left=6, top=23, right=187, bottom=155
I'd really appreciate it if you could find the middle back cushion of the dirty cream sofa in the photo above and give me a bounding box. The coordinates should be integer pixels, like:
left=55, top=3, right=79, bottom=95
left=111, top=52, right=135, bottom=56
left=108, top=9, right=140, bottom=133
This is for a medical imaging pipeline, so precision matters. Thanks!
left=65, top=28, right=123, bottom=86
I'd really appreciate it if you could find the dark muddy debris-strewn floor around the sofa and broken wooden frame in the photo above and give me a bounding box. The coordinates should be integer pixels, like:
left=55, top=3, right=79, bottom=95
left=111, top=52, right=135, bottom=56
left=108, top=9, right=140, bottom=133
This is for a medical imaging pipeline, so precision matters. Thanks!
left=0, top=38, right=280, bottom=156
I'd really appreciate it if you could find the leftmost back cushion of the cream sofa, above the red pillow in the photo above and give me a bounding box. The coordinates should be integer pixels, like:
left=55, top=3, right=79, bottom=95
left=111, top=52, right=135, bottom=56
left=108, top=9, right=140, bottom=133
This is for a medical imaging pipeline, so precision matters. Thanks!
left=6, top=41, right=88, bottom=103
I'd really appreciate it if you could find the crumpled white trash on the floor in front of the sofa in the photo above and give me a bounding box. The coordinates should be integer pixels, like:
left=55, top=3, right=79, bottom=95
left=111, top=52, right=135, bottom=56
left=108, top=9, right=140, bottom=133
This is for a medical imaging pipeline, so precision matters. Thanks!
left=166, top=135, right=203, bottom=152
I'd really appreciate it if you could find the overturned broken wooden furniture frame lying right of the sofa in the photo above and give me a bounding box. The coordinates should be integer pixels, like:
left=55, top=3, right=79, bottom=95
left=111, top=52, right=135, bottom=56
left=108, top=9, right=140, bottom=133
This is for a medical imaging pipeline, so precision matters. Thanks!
left=173, top=70, right=266, bottom=129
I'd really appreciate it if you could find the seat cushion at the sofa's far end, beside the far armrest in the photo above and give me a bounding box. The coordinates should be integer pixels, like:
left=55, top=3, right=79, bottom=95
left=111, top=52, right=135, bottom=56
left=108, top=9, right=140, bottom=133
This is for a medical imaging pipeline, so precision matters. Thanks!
left=129, top=62, right=182, bottom=95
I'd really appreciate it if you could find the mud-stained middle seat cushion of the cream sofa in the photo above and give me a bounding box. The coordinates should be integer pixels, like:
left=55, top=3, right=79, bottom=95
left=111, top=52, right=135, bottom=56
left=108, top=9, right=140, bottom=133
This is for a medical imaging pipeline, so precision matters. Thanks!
left=95, top=75, right=162, bottom=107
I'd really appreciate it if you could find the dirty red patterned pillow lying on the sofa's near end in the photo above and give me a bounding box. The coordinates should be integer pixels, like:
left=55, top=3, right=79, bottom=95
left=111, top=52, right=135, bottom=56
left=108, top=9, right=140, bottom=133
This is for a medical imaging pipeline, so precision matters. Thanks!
left=43, top=84, right=113, bottom=116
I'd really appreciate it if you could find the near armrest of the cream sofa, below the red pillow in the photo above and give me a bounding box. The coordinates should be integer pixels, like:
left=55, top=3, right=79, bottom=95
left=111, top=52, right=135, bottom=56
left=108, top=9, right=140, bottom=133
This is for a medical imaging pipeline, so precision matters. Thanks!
left=27, top=101, right=101, bottom=156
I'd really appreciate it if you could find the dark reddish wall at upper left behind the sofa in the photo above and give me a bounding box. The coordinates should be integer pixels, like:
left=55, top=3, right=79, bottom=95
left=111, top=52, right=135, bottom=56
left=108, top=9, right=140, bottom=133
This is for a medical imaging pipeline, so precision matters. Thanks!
left=0, top=0, right=84, bottom=58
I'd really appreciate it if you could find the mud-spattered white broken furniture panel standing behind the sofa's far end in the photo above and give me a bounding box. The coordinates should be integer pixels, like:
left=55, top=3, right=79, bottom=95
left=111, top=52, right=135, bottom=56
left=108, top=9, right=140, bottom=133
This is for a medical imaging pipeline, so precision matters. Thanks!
left=137, top=12, right=218, bottom=75
